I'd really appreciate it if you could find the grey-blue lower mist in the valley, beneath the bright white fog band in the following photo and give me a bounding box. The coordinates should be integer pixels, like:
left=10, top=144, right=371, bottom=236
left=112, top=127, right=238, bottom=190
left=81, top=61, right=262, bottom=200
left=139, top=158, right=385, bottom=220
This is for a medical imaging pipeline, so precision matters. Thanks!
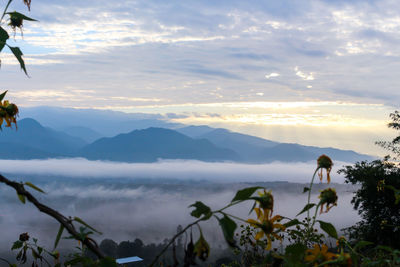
left=0, top=172, right=359, bottom=255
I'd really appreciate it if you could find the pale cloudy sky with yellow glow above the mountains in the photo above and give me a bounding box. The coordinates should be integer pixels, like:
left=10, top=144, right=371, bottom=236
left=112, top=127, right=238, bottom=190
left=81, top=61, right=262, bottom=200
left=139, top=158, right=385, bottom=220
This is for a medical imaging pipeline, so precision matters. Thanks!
left=0, top=0, right=400, bottom=155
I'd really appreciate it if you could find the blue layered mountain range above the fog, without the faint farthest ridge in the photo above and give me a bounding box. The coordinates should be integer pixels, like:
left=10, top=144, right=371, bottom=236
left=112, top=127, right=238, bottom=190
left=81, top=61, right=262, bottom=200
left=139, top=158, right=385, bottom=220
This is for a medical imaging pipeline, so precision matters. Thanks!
left=0, top=118, right=373, bottom=163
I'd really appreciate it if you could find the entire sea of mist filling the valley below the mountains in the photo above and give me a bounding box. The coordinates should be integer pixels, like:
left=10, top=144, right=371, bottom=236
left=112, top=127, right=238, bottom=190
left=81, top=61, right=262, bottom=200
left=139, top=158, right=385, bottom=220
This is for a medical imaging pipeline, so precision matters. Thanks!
left=0, top=159, right=359, bottom=262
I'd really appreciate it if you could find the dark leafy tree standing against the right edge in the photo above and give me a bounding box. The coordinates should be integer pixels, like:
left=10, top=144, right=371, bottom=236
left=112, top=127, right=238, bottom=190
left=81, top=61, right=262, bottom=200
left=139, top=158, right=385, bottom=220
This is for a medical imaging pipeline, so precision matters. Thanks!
left=339, top=111, right=400, bottom=249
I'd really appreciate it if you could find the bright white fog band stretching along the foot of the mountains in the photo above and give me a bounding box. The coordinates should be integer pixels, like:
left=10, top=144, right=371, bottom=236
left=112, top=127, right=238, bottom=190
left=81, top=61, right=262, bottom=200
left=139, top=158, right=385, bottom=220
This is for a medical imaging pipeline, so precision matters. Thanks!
left=0, top=158, right=350, bottom=183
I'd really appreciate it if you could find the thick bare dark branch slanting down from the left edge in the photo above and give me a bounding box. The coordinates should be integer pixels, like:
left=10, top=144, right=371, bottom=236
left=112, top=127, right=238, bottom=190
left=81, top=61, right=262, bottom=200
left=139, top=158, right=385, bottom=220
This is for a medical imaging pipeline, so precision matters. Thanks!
left=0, top=174, right=105, bottom=259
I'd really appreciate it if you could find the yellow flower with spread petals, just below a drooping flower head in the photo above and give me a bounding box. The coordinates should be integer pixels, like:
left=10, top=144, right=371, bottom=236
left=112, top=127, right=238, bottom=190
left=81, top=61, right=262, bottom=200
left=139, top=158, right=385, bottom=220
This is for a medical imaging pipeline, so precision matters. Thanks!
left=247, top=208, right=285, bottom=250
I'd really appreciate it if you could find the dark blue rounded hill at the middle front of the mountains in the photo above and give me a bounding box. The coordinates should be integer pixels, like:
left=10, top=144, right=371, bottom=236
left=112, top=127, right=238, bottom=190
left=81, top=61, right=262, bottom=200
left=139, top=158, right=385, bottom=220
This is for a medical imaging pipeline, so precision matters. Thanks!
left=79, top=128, right=240, bottom=162
